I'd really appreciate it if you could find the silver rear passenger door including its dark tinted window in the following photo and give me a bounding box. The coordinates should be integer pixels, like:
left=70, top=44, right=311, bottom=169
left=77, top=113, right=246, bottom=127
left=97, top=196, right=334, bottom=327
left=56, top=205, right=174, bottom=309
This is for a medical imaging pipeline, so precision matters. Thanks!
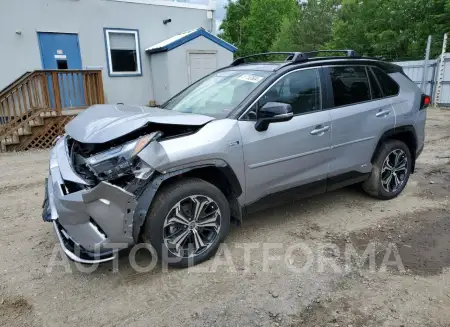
left=324, top=65, right=395, bottom=183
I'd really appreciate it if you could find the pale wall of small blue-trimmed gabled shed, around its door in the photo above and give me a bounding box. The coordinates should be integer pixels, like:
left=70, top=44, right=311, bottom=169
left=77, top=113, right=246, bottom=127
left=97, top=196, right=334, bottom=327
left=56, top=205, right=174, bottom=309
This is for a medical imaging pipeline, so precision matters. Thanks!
left=167, top=36, right=233, bottom=100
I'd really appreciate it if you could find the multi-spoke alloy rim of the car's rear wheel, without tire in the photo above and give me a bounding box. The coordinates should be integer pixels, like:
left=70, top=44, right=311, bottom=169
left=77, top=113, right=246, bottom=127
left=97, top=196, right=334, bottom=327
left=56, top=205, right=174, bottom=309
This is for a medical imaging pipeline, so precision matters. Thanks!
left=381, top=149, right=408, bottom=193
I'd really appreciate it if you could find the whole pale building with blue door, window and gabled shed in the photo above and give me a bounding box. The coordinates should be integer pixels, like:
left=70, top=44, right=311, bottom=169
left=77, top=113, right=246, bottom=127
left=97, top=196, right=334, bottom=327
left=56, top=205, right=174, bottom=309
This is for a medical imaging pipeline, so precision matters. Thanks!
left=0, top=0, right=236, bottom=105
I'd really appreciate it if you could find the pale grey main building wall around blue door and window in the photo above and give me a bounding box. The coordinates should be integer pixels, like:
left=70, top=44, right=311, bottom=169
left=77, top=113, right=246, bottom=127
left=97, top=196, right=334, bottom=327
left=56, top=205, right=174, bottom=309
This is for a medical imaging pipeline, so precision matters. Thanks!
left=0, top=0, right=211, bottom=104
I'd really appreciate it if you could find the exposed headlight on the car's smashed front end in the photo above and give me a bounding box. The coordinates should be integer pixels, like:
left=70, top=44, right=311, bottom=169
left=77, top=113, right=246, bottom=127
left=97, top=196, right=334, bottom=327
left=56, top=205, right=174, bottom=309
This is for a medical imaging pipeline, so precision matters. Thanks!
left=86, top=132, right=159, bottom=180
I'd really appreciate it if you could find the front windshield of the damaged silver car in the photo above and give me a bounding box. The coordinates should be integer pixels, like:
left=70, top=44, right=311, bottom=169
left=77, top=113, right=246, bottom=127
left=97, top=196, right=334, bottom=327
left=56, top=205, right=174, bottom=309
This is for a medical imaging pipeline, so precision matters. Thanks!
left=163, top=70, right=271, bottom=118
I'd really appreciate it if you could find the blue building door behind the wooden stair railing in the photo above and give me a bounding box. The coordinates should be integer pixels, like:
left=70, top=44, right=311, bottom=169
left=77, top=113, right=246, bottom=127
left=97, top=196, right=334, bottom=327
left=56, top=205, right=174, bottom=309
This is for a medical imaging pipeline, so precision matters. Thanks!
left=38, top=32, right=85, bottom=108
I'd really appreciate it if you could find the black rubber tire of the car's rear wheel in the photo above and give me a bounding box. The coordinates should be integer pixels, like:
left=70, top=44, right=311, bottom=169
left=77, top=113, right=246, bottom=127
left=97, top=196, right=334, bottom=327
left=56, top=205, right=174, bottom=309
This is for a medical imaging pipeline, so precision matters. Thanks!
left=363, top=140, right=413, bottom=200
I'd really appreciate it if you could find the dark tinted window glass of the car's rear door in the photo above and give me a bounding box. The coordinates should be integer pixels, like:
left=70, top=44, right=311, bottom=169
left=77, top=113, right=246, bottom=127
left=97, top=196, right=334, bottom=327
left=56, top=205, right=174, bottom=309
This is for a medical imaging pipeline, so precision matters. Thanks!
left=331, top=66, right=371, bottom=107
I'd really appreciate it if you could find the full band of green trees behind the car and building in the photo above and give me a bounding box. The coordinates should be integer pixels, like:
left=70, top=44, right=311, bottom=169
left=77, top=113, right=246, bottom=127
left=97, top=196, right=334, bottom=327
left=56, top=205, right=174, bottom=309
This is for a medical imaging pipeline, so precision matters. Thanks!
left=221, top=0, right=450, bottom=60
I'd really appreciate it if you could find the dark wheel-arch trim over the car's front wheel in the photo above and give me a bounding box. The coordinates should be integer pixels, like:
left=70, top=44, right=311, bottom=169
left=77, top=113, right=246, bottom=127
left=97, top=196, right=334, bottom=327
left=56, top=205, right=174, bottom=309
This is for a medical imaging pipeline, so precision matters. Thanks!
left=133, top=159, right=242, bottom=243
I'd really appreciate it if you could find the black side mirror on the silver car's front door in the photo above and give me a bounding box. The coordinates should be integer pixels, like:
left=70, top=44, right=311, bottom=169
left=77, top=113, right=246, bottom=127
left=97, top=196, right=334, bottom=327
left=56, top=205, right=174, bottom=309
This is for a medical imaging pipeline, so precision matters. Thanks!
left=255, top=102, right=294, bottom=132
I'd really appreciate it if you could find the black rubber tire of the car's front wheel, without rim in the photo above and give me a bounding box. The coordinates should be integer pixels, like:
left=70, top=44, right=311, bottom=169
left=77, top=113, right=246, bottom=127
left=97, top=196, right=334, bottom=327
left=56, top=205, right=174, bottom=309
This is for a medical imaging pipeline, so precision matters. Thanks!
left=142, top=178, right=230, bottom=268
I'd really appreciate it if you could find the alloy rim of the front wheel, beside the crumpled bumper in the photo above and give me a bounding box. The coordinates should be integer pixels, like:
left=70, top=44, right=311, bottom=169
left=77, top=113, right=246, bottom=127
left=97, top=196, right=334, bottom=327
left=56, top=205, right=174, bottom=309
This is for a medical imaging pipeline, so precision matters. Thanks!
left=163, top=195, right=222, bottom=258
